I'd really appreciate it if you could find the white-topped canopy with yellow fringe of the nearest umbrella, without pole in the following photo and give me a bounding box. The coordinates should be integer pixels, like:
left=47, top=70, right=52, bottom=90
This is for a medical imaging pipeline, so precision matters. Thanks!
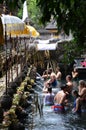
left=1, top=14, right=25, bottom=34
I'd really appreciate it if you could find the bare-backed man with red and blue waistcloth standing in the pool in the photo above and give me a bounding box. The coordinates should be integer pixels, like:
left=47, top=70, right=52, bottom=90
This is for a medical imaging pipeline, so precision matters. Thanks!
left=53, top=84, right=68, bottom=112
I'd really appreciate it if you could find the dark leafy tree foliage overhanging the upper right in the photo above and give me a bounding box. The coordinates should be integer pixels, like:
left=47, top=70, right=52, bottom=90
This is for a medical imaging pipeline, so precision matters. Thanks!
left=37, top=0, right=86, bottom=62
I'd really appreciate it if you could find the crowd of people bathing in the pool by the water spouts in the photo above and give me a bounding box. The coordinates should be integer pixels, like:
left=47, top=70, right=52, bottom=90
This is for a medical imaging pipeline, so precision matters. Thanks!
left=42, top=67, right=86, bottom=113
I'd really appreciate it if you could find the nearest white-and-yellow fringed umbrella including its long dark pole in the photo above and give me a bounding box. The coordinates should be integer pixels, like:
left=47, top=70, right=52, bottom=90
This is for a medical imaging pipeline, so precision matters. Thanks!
left=1, top=14, right=25, bottom=94
